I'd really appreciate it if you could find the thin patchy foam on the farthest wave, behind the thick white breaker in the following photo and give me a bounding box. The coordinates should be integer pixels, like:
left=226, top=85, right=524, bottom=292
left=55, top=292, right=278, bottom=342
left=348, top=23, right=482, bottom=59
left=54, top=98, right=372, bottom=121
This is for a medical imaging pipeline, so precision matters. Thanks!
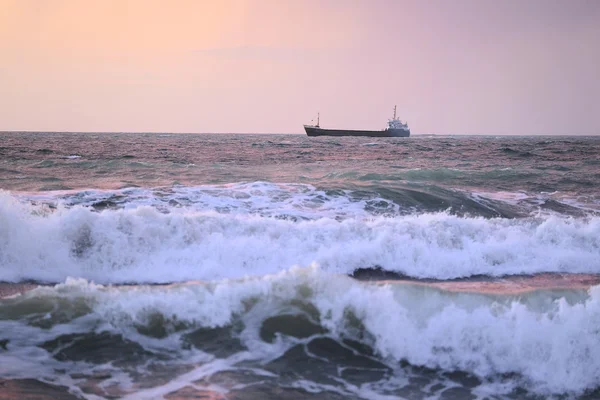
left=15, top=182, right=399, bottom=219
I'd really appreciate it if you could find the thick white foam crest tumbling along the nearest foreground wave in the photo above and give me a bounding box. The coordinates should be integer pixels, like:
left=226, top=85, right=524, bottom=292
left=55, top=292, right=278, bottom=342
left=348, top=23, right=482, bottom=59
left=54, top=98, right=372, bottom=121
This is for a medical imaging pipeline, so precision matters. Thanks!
left=0, top=268, right=600, bottom=395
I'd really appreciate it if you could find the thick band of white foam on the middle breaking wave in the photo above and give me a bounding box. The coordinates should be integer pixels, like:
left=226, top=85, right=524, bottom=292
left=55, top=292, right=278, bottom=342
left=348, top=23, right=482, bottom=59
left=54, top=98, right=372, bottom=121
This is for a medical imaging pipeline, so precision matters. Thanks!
left=0, top=189, right=600, bottom=283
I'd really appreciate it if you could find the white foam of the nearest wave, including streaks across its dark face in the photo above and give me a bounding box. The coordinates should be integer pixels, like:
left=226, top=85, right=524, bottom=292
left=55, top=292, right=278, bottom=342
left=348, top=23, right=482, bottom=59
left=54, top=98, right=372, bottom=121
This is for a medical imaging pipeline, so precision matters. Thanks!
left=0, top=267, right=600, bottom=398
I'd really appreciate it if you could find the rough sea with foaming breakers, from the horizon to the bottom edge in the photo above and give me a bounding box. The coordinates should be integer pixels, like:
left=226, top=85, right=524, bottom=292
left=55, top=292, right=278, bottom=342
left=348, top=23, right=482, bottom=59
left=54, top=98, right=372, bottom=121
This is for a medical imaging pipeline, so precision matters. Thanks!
left=0, top=132, right=600, bottom=400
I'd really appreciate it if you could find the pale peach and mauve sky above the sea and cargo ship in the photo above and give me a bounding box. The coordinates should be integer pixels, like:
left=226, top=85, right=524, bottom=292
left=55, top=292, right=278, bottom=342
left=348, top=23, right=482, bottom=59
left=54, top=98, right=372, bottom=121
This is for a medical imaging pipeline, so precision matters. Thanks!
left=0, top=0, right=600, bottom=135
